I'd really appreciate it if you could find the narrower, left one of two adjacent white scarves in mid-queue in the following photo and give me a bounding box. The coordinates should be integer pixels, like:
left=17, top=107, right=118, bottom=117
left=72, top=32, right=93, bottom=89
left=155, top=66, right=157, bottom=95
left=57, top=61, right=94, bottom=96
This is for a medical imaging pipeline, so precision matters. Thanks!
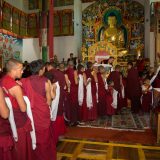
left=78, top=74, right=84, bottom=106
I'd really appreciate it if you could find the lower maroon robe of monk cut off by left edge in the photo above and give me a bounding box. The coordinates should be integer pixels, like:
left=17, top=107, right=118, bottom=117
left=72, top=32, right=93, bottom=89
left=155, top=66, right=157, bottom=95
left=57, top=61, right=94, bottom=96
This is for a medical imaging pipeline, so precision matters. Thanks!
left=0, top=114, right=14, bottom=160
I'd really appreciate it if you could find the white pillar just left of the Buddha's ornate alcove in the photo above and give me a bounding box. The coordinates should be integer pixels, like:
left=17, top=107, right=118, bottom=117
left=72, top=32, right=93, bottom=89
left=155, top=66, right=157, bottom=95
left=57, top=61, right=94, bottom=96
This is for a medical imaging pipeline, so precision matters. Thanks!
left=74, top=0, right=82, bottom=58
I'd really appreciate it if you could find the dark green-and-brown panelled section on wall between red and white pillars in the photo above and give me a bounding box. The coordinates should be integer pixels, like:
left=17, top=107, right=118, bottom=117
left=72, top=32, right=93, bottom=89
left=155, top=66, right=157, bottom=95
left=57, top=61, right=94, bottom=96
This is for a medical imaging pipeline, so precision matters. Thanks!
left=54, top=9, right=73, bottom=36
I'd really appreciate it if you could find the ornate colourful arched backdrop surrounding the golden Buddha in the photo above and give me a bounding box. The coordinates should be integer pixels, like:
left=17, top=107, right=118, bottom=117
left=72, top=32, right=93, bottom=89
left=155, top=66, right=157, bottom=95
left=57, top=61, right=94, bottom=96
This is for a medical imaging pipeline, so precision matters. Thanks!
left=82, top=0, right=144, bottom=50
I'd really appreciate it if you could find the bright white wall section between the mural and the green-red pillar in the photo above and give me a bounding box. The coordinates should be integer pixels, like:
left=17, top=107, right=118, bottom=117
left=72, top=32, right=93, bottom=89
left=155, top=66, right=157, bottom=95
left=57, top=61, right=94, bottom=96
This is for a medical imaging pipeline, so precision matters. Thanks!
left=22, top=38, right=41, bottom=62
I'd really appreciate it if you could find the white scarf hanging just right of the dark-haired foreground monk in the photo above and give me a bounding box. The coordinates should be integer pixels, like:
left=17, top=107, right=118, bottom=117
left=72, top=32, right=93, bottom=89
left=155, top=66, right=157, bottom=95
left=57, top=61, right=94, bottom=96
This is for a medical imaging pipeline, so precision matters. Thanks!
left=51, top=82, right=60, bottom=121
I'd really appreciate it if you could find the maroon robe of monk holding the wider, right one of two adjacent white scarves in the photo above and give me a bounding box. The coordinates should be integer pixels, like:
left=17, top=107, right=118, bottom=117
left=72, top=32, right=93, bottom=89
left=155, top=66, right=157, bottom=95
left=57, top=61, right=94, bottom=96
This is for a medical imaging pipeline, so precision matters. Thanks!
left=85, top=69, right=97, bottom=120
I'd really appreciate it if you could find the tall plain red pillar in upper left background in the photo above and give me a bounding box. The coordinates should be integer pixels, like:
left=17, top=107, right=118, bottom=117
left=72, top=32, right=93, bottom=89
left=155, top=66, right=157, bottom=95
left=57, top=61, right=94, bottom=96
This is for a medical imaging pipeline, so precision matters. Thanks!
left=48, top=0, right=54, bottom=61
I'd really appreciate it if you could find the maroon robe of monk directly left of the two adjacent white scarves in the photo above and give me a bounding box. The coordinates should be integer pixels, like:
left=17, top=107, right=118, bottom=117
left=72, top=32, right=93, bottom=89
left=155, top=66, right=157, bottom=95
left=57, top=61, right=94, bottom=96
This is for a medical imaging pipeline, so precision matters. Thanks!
left=66, top=68, right=79, bottom=123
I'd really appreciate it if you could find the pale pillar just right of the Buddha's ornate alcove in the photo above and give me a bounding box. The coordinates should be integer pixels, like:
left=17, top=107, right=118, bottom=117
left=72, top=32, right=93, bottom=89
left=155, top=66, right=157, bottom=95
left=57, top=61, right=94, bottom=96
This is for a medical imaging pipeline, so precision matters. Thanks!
left=144, top=0, right=152, bottom=58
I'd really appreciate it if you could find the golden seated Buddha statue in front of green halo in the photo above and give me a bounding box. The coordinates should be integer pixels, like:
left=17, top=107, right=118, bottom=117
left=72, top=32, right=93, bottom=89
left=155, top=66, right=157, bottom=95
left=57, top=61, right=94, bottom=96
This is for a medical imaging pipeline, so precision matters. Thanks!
left=100, top=16, right=124, bottom=48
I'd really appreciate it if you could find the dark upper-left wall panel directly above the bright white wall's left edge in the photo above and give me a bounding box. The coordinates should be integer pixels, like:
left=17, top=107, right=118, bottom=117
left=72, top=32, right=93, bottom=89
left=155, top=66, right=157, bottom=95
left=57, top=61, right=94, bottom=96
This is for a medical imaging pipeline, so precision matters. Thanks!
left=20, top=12, right=27, bottom=36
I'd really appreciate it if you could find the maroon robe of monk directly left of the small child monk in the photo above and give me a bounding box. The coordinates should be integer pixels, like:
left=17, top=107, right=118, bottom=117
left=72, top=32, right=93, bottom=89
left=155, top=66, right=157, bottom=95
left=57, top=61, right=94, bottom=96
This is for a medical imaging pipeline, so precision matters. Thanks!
left=97, top=73, right=106, bottom=116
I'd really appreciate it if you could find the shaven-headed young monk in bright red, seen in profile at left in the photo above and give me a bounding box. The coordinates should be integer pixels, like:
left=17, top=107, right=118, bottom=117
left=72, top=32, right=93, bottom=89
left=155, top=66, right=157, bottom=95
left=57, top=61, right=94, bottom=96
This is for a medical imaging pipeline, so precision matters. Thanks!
left=1, top=59, right=33, bottom=160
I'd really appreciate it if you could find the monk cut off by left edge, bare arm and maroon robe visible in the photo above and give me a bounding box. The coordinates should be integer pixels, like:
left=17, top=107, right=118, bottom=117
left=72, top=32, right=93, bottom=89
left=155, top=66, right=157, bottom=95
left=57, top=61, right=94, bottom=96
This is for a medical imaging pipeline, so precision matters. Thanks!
left=0, top=87, right=13, bottom=160
